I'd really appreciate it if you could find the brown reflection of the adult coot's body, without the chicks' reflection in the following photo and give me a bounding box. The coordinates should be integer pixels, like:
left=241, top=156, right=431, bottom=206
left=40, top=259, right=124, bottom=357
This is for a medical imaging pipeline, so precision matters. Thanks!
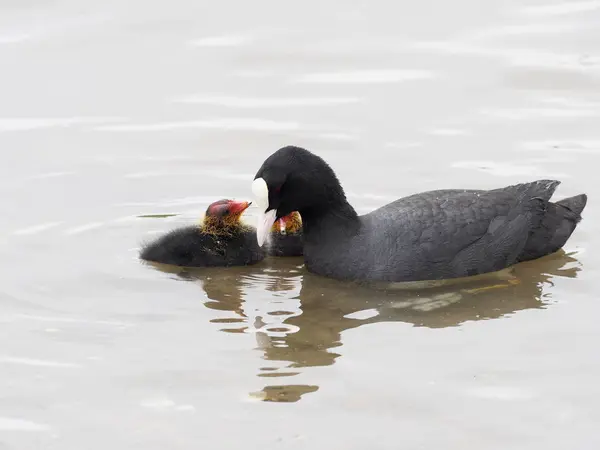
left=264, top=251, right=580, bottom=369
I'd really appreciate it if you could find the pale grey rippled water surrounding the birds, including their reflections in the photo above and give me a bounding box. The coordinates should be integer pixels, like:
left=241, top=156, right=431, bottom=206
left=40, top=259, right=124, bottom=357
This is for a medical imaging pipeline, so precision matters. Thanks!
left=0, top=0, right=600, bottom=450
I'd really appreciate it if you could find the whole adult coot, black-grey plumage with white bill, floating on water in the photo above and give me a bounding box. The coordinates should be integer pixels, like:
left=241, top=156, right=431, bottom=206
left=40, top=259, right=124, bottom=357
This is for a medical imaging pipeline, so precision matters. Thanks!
left=252, top=146, right=587, bottom=281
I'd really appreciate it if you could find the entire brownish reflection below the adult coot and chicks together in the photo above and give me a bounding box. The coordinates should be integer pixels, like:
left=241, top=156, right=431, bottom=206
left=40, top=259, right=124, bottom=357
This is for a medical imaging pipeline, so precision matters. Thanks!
left=144, top=251, right=580, bottom=402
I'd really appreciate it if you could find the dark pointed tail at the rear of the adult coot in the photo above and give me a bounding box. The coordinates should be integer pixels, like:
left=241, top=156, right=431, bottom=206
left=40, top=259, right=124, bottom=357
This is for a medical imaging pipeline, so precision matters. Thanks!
left=518, top=194, right=587, bottom=261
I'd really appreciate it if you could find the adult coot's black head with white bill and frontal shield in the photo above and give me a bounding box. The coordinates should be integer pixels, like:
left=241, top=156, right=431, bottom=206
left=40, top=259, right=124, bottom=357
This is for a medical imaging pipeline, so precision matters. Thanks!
left=252, top=146, right=355, bottom=245
